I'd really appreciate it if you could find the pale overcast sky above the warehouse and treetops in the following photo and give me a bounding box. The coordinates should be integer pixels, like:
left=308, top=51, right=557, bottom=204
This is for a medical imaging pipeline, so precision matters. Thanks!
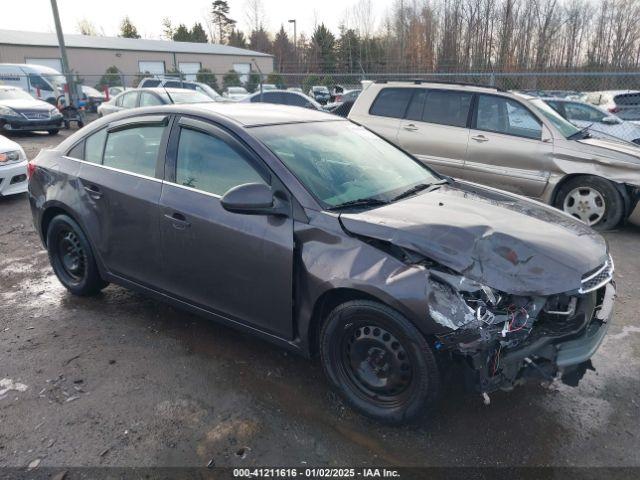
left=7, top=0, right=393, bottom=38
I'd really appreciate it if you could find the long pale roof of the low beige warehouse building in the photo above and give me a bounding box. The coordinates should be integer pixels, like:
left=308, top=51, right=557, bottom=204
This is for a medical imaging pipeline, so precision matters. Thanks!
left=0, top=30, right=272, bottom=57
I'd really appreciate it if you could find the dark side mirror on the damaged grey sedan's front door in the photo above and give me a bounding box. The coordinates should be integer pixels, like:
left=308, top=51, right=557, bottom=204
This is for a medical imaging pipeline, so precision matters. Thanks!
left=220, top=183, right=288, bottom=215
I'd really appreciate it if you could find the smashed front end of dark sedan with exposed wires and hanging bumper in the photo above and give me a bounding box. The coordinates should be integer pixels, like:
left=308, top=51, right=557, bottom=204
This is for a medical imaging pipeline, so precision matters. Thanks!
left=427, top=258, right=615, bottom=399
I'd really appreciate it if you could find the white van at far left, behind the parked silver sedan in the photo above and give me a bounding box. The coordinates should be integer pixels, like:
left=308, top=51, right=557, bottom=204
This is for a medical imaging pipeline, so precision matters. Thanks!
left=0, top=63, right=66, bottom=105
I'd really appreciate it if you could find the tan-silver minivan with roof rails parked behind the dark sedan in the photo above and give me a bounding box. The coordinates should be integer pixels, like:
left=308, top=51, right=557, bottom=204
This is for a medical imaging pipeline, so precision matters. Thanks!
left=349, top=81, right=640, bottom=230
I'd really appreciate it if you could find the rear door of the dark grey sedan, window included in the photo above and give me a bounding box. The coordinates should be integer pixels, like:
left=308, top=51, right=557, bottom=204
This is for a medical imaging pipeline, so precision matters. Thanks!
left=79, top=115, right=168, bottom=285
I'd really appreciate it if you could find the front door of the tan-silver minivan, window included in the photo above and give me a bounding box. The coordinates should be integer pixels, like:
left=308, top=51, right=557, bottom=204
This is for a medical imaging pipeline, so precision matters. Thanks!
left=462, top=94, right=553, bottom=197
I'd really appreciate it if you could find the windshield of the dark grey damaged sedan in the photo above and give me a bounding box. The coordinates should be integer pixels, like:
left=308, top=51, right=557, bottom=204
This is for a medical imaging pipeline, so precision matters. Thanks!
left=252, top=121, right=440, bottom=208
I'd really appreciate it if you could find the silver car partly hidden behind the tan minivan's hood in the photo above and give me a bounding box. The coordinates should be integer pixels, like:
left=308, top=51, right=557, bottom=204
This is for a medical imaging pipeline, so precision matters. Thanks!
left=544, top=98, right=640, bottom=145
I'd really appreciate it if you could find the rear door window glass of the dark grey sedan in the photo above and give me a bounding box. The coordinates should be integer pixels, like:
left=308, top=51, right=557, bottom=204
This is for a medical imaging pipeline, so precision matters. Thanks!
left=103, top=125, right=165, bottom=177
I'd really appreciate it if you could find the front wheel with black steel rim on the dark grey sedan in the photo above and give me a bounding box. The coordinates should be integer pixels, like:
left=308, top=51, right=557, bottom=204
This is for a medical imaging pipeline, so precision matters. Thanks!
left=320, top=300, right=440, bottom=425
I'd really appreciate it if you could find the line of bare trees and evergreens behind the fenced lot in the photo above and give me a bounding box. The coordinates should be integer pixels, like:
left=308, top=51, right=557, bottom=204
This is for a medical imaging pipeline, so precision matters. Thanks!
left=79, top=0, right=640, bottom=73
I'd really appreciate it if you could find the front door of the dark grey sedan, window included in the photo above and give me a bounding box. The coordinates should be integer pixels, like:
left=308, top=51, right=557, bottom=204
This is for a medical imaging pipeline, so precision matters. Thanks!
left=160, top=118, right=293, bottom=338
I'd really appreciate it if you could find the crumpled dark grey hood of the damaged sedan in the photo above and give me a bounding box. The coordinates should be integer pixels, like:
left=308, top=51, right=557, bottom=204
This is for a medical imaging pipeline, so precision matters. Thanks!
left=340, top=182, right=607, bottom=295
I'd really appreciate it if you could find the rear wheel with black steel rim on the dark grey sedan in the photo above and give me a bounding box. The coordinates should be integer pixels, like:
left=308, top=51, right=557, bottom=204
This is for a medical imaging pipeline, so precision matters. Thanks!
left=47, top=215, right=108, bottom=296
